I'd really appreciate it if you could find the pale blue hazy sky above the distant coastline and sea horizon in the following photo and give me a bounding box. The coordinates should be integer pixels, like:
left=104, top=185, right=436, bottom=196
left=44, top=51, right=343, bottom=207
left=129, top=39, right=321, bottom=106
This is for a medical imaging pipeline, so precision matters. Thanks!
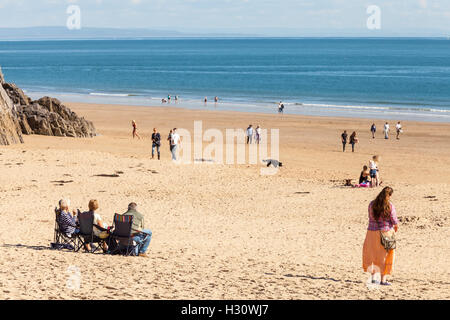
left=0, top=0, right=450, bottom=36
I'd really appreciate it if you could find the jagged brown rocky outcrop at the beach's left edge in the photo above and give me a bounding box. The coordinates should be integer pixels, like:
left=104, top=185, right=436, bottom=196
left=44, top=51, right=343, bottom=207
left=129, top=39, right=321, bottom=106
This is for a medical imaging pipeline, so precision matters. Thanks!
left=0, top=66, right=96, bottom=144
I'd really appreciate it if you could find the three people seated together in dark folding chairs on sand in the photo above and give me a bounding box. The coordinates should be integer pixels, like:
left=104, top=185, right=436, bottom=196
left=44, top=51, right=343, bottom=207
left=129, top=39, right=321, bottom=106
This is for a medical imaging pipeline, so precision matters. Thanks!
left=51, top=199, right=152, bottom=257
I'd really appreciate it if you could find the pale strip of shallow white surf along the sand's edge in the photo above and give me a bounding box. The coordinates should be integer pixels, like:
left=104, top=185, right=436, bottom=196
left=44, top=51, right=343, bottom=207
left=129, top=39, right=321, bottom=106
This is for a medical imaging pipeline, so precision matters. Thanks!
left=20, top=91, right=450, bottom=123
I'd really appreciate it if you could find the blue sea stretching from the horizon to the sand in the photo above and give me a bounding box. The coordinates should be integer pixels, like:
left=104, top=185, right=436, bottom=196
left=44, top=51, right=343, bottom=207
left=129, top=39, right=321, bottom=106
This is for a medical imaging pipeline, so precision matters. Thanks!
left=0, top=39, right=450, bottom=121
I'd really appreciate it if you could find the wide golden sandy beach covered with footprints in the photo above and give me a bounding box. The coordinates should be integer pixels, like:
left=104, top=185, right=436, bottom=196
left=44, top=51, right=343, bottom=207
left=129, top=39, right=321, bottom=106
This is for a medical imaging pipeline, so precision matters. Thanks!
left=0, top=103, right=450, bottom=299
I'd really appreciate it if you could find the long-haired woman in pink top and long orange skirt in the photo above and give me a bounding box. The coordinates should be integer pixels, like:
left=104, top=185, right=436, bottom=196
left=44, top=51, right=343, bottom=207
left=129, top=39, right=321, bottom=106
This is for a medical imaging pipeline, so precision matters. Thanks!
left=363, top=187, right=399, bottom=286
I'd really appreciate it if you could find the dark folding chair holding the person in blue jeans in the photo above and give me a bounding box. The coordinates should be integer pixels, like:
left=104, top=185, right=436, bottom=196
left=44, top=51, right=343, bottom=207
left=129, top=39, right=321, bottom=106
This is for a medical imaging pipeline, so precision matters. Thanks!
left=108, top=213, right=141, bottom=256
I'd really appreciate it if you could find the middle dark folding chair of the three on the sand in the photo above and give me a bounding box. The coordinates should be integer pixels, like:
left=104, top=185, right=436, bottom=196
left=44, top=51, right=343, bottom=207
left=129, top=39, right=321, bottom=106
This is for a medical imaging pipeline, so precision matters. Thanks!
left=75, top=210, right=108, bottom=253
